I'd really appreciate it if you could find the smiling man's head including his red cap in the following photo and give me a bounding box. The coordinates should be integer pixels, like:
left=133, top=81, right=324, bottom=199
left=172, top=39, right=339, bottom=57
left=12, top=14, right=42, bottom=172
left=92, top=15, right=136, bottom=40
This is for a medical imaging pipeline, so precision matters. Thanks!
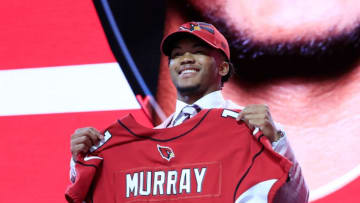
left=161, top=22, right=232, bottom=100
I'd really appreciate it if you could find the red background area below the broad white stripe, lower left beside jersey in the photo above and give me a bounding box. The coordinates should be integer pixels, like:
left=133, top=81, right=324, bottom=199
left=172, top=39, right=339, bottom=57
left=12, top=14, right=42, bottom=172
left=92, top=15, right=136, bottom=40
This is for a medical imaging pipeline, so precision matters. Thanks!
left=0, top=109, right=151, bottom=203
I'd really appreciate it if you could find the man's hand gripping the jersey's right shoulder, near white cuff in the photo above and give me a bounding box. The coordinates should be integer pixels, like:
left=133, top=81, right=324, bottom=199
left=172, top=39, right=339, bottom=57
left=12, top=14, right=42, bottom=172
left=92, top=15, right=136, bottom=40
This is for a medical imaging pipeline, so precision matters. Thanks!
left=236, top=104, right=280, bottom=142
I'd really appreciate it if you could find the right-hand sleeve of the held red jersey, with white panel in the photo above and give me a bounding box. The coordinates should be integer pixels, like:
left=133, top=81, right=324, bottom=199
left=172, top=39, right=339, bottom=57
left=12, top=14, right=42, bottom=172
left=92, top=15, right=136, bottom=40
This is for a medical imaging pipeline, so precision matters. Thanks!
left=235, top=132, right=292, bottom=203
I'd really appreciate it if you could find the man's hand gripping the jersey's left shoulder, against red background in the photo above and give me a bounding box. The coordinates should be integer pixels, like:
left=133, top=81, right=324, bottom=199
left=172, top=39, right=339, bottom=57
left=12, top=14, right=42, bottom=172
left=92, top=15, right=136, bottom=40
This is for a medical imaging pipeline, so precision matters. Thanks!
left=70, top=127, right=104, bottom=161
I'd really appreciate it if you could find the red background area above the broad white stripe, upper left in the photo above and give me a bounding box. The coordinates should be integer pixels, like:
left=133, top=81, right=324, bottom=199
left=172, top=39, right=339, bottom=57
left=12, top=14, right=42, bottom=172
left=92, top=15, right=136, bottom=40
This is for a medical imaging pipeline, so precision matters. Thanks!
left=0, top=0, right=116, bottom=69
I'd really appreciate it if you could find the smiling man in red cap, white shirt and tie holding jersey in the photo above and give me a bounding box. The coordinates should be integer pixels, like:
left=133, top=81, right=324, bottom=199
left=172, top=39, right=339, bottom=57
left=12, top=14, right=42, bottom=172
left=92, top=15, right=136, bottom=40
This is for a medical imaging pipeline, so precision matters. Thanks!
left=71, top=22, right=308, bottom=203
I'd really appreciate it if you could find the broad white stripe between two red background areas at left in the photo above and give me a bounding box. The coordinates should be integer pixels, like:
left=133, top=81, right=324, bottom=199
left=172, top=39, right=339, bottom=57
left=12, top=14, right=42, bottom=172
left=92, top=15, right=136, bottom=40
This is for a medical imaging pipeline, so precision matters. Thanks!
left=0, top=63, right=140, bottom=116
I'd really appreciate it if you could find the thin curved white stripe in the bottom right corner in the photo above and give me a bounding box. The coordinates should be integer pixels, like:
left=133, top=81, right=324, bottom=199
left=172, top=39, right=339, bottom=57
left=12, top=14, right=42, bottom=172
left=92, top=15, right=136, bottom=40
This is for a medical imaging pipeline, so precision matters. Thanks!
left=309, top=165, right=360, bottom=201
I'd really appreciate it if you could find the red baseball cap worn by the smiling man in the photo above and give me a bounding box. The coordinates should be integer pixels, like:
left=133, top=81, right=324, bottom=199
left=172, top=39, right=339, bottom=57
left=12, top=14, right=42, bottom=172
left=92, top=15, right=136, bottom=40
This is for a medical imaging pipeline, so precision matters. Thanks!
left=161, top=22, right=230, bottom=61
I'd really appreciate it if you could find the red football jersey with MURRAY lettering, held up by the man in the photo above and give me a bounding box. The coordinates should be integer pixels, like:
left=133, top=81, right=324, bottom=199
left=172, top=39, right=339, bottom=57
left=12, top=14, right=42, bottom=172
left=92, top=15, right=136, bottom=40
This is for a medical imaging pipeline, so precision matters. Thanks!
left=66, top=109, right=291, bottom=203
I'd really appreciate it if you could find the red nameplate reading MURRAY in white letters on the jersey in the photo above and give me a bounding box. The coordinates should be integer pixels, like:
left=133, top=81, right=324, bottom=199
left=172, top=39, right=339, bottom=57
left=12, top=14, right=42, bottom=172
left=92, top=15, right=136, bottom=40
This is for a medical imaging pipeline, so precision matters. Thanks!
left=119, top=163, right=221, bottom=200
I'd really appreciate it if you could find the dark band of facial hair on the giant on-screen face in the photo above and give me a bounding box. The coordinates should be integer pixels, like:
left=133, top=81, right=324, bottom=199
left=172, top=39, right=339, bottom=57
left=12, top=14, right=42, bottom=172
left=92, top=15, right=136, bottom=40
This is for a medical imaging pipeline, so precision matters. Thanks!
left=195, top=5, right=360, bottom=81
